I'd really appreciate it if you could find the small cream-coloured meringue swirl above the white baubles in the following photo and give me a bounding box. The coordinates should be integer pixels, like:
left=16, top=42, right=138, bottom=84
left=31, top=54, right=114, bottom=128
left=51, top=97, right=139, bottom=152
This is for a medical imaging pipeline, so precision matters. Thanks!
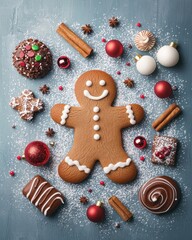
left=134, top=30, right=155, bottom=51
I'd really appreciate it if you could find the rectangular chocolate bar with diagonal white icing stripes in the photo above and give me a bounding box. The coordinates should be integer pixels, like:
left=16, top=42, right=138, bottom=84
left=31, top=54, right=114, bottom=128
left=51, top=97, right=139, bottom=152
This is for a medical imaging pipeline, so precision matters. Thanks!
left=23, top=175, right=64, bottom=216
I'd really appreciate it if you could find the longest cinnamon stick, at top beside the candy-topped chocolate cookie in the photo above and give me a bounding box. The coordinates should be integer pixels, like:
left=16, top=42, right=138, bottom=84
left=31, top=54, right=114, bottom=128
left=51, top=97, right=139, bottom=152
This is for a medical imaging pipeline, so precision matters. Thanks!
left=57, top=23, right=93, bottom=58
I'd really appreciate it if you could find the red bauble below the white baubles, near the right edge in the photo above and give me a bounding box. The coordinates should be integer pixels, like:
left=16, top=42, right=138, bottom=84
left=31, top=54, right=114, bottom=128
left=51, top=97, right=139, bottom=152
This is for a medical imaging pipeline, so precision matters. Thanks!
left=154, top=81, right=173, bottom=98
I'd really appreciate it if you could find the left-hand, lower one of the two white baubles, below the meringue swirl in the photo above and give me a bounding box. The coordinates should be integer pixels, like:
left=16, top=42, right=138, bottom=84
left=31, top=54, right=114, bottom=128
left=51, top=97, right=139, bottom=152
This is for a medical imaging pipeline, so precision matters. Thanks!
left=136, top=55, right=156, bottom=75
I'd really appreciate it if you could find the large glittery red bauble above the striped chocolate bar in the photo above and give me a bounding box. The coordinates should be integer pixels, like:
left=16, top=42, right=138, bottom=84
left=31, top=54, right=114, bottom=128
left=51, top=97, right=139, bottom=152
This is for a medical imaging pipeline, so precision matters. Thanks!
left=25, top=141, right=50, bottom=166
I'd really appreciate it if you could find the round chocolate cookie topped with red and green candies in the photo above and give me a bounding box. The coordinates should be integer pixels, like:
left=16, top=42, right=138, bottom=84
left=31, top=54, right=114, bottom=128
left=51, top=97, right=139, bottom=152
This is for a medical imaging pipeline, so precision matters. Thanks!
left=12, top=39, right=52, bottom=79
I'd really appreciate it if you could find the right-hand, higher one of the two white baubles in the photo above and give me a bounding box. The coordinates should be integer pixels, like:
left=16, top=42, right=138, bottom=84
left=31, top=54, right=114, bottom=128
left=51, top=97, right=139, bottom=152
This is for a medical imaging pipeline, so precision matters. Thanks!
left=157, top=45, right=179, bottom=67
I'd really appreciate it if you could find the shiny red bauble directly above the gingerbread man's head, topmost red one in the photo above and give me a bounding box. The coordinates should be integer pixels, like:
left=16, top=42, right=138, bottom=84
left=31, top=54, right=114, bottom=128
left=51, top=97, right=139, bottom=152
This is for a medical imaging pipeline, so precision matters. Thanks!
left=105, top=39, right=123, bottom=58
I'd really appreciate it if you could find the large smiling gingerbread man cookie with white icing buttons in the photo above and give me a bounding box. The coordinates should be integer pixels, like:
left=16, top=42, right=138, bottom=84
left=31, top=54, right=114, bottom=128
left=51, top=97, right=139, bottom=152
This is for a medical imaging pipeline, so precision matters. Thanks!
left=51, top=70, right=144, bottom=183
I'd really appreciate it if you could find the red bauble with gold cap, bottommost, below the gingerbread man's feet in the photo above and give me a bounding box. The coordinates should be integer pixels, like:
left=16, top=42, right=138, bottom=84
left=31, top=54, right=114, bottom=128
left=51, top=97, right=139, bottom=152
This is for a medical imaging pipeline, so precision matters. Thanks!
left=87, top=201, right=105, bottom=222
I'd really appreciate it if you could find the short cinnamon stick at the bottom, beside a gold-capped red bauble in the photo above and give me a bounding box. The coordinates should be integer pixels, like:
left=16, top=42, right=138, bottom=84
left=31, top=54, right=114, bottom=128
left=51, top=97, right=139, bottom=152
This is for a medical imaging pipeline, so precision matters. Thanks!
left=108, top=196, right=133, bottom=222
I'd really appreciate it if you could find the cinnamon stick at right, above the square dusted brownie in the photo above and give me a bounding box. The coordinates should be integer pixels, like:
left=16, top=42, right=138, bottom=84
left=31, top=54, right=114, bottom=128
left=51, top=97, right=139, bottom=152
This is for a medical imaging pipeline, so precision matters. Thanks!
left=152, top=103, right=181, bottom=131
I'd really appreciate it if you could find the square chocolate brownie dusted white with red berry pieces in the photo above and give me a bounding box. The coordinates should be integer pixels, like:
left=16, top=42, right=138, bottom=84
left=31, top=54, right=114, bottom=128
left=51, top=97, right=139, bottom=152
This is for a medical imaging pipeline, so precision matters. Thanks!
left=151, top=136, right=177, bottom=165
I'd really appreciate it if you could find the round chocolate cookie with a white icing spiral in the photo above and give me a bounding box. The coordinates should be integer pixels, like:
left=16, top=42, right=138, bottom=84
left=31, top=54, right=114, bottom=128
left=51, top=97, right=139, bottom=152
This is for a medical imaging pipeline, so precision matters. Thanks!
left=139, top=176, right=180, bottom=214
